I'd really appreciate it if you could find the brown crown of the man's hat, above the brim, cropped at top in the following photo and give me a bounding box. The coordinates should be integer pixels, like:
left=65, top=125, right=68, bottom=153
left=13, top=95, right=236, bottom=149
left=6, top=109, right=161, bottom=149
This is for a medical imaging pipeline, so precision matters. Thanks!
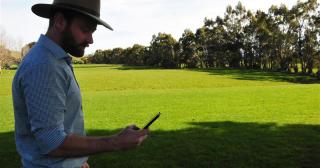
left=53, top=0, right=100, bottom=16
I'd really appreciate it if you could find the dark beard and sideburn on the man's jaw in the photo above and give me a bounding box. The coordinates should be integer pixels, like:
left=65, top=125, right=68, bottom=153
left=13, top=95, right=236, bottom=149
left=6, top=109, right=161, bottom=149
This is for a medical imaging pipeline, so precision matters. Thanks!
left=61, top=26, right=89, bottom=57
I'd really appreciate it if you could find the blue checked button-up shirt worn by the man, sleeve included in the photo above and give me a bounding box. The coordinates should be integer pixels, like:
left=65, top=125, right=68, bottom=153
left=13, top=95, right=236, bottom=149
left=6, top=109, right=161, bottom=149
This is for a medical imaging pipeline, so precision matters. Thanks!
left=12, top=35, right=87, bottom=168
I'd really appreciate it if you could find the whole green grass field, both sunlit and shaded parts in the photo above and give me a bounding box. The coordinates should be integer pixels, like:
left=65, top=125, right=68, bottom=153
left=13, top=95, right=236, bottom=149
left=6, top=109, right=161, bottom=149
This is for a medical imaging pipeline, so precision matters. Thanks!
left=0, top=65, right=320, bottom=168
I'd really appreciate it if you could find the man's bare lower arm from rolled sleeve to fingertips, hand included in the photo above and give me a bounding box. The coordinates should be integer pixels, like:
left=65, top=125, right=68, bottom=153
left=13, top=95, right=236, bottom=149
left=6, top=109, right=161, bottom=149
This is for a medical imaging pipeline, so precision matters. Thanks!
left=49, top=125, right=149, bottom=157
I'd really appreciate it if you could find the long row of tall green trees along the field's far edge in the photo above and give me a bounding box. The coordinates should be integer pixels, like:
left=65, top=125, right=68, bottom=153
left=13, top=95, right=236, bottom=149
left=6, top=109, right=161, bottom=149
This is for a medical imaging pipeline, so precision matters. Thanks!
left=88, top=0, right=320, bottom=76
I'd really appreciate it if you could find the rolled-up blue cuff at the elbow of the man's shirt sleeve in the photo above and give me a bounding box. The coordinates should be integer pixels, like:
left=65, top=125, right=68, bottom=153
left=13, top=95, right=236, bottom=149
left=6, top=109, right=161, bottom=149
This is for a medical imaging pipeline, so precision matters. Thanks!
left=34, top=126, right=67, bottom=154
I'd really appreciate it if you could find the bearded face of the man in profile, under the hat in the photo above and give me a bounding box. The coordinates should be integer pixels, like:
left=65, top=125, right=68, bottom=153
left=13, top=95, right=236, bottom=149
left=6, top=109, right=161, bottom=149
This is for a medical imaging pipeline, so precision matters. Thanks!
left=61, top=17, right=97, bottom=57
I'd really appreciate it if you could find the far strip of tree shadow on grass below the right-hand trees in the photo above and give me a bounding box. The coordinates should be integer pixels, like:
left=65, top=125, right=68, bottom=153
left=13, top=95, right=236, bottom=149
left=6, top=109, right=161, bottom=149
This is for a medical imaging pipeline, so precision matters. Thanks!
left=190, top=68, right=320, bottom=84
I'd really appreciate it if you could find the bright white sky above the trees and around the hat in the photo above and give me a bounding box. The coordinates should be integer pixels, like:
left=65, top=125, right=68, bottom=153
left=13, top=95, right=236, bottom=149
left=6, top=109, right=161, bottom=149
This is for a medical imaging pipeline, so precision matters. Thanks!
left=0, top=0, right=297, bottom=54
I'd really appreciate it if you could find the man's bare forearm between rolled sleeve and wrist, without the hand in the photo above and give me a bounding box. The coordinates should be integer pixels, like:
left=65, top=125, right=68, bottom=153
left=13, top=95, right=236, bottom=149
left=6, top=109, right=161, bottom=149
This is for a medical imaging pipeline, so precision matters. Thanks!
left=49, top=134, right=117, bottom=157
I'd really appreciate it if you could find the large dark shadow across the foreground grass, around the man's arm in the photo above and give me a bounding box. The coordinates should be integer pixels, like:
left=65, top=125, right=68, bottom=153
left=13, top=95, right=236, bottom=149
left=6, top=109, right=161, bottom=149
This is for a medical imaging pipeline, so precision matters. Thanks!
left=0, top=121, right=320, bottom=168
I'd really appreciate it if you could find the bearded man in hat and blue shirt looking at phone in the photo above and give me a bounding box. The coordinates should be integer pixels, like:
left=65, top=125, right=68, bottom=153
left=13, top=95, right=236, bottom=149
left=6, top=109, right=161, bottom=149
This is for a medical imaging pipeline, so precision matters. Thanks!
left=12, top=0, right=148, bottom=168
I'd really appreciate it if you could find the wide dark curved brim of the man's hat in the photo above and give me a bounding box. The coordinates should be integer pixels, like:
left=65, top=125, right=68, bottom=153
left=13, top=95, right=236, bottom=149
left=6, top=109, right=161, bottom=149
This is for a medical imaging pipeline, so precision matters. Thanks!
left=31, top=4, right=113, bottom=30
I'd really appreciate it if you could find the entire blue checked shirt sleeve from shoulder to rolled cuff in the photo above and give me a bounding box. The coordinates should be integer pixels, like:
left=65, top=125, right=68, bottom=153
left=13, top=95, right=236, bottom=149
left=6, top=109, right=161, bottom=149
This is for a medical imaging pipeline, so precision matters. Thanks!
left=21, top=64, right=68, bottom=154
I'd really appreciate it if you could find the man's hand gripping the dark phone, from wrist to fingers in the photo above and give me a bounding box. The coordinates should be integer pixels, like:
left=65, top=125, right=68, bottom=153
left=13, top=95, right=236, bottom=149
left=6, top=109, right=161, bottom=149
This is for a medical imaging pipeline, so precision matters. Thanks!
left=112, top=125, right=149, bottom=150
